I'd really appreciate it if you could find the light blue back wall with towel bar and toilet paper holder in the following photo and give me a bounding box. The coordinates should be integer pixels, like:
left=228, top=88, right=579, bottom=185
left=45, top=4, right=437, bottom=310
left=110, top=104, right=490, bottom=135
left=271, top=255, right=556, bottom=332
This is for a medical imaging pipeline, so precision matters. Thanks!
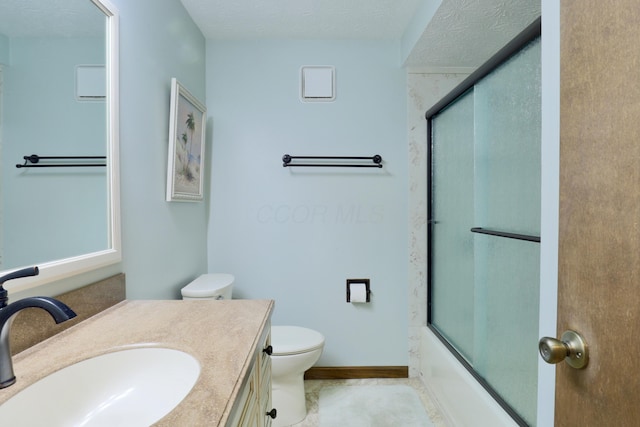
left=207, top=40, right=408, bottom=366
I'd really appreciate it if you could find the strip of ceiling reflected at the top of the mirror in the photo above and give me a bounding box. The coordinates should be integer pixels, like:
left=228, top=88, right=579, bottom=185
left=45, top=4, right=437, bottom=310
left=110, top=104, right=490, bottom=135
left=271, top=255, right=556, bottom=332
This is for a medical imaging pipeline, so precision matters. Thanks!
left=0, top=0, right=105, bottom=37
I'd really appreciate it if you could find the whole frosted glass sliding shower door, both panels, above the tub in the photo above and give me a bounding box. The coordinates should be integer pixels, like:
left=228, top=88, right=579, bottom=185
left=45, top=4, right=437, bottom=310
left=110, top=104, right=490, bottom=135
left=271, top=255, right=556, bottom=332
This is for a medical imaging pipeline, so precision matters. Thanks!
left=429, top=38, right=541, bottom=425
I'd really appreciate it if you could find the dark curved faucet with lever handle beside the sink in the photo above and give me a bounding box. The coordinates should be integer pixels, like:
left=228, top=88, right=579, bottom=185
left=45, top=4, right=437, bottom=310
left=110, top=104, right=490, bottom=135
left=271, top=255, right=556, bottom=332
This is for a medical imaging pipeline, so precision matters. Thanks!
left=0, top=267, right=76, bottom=389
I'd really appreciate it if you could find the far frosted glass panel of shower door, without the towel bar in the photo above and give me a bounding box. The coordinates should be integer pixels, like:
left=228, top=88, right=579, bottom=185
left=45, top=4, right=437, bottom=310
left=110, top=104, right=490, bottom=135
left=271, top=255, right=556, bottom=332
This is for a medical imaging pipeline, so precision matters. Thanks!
left=429, top=91, right=475, bottom=363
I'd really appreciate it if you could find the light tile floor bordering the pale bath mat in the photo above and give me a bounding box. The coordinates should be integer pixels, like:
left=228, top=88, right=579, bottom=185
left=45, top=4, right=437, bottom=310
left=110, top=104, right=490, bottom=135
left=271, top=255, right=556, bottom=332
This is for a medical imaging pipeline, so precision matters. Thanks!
left=294, top=378, right=447, bottom=427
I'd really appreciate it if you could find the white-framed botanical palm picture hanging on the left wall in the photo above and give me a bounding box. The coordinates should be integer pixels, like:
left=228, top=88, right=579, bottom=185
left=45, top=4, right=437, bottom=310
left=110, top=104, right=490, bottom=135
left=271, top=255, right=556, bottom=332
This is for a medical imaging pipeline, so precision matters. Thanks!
left=167, top=78, right=207, bottom=201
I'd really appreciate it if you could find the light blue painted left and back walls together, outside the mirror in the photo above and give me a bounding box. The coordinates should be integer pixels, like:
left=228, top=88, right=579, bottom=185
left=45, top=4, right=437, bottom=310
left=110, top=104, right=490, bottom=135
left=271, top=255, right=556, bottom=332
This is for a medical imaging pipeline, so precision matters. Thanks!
left=6, top=0, right=408, bottom=366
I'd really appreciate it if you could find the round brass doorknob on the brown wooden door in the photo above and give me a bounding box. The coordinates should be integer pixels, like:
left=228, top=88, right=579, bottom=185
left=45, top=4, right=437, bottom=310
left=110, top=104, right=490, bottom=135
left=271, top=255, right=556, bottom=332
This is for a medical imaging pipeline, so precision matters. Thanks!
left=538, top=331, right=589, bottom=369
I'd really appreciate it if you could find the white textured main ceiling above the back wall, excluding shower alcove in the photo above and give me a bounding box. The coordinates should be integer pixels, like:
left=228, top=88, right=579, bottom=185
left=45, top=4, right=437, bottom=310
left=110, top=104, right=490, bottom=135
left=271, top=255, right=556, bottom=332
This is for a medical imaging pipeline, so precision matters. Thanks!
left=181, top=0, right=424, bottom=39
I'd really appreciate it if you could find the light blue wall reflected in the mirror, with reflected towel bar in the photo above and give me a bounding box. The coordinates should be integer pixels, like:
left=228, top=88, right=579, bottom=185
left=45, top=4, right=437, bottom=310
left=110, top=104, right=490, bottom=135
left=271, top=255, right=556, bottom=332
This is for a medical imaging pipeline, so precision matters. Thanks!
left=1, top=37, right=107, bottom=269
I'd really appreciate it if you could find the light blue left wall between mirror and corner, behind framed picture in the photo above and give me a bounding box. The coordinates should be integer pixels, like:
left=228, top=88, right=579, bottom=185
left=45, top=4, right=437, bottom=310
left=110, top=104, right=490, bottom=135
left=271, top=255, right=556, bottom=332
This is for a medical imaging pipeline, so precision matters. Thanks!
left=112, top=0, right=210, bottom=299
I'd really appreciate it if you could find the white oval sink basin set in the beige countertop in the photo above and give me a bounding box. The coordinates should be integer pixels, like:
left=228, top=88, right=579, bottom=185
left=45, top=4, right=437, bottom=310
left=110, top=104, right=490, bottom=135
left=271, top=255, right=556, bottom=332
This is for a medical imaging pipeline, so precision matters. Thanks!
left=0, top=347, right=200, bottom=427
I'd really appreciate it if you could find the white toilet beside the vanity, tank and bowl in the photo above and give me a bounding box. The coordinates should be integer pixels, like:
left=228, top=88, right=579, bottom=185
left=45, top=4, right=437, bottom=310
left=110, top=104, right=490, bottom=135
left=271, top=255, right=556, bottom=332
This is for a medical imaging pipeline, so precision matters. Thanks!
left=181, top=273, right=324, bottom=427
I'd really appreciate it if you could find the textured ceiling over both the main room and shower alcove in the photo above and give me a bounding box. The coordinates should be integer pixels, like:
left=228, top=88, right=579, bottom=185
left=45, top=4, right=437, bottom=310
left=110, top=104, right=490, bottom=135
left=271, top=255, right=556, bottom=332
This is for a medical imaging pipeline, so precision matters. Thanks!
left=181, top=0, right=540, bottom=67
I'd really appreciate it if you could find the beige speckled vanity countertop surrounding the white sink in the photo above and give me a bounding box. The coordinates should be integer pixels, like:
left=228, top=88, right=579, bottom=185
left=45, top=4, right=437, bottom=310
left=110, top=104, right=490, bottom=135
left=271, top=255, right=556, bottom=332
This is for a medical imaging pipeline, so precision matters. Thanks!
left=0, top=300, right=273, bottom=426
